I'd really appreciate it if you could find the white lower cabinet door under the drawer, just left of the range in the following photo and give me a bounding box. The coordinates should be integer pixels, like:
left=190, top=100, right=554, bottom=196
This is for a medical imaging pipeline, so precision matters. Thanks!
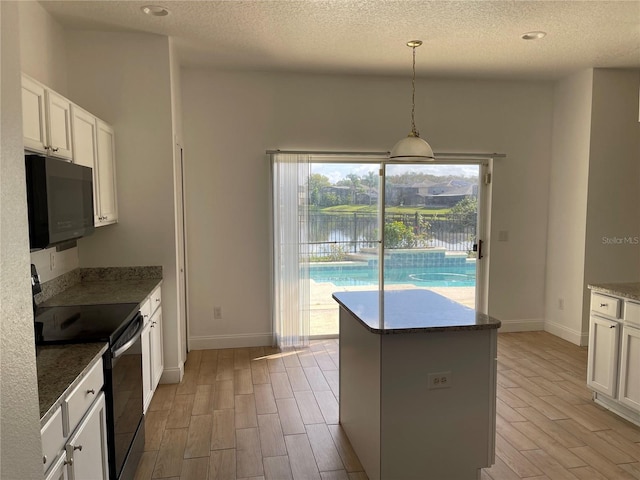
left=66, top=392, right=109, bottom=480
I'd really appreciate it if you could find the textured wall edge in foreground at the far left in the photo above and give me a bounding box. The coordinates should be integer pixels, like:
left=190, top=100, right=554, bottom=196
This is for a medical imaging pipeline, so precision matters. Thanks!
left=0, top=2, right=43, bottom=480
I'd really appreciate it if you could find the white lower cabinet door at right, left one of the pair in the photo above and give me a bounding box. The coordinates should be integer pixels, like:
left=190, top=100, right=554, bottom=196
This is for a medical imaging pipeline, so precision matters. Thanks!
left=587, top=315, right=621, bottom=398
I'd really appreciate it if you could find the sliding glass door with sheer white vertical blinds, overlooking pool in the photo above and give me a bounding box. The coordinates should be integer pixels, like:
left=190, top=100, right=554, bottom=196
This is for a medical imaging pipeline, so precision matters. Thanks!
left=274, top=154, right=489, bottom=343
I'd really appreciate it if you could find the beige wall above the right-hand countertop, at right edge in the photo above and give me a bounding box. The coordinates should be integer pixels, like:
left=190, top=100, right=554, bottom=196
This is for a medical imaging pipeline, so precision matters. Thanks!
left=583, top=69, right=640, bottom=286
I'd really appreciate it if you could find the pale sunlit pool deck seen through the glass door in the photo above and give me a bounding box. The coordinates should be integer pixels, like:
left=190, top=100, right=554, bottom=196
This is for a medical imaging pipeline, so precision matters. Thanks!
left=310, top=280, right=476, bottom=337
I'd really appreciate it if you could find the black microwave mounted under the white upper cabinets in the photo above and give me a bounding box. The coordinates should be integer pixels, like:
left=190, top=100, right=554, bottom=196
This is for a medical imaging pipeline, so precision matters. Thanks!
left=25, top=155, right=94, bottom=250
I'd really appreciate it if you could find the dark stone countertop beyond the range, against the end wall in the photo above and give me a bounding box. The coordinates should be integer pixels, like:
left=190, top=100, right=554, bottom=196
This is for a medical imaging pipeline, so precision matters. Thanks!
left=39, top=278, right=162, bottom=307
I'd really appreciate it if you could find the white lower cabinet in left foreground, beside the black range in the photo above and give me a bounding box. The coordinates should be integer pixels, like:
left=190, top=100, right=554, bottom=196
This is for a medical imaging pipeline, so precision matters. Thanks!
left=41, top=359, right=109, bottom=480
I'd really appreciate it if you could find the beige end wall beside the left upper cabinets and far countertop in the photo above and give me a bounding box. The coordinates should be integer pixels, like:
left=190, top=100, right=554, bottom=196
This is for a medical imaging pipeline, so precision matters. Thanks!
left=66, top=31, right=182, bottom=382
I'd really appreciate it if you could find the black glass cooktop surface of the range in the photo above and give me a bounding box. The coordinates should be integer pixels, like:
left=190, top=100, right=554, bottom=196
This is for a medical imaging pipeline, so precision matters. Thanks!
left=34, top=303, right=138, bottom=345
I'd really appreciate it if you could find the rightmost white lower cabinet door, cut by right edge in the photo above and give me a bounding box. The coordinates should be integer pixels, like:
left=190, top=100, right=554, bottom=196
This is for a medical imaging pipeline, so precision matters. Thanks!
left=618, top=326, right=640, bottom=413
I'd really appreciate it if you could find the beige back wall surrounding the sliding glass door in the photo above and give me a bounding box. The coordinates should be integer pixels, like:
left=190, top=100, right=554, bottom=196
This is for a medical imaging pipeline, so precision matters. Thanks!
left=182, top=69, right=553, bottom=346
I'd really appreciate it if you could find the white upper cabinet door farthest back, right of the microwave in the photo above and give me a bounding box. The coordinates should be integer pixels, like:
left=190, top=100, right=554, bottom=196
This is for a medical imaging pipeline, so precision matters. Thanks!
left=96, top=119, right=118, bottom=226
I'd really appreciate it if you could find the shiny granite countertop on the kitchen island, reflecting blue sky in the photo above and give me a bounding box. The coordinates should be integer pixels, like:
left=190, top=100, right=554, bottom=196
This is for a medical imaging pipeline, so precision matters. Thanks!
left=333, top=289, right=501, bottom=334
